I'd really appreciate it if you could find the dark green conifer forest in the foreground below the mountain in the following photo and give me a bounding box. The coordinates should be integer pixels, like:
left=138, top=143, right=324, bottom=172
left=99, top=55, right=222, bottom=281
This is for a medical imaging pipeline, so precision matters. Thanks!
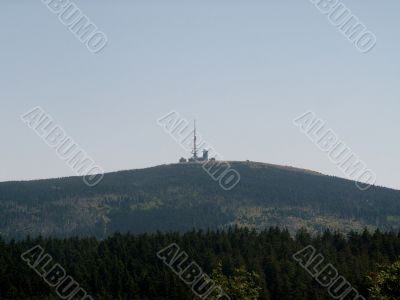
left=0, top=227, right=400, bottom=300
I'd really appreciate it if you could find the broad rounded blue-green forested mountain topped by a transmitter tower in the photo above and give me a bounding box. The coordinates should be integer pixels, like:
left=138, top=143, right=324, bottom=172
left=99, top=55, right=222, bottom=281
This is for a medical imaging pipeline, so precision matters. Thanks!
left=0, top=161, right=400, bottom=238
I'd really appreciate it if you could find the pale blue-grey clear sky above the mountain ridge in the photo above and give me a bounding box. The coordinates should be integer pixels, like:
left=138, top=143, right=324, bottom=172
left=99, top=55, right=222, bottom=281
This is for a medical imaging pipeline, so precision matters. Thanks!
left=0, top=0, right=400, bottom=189
